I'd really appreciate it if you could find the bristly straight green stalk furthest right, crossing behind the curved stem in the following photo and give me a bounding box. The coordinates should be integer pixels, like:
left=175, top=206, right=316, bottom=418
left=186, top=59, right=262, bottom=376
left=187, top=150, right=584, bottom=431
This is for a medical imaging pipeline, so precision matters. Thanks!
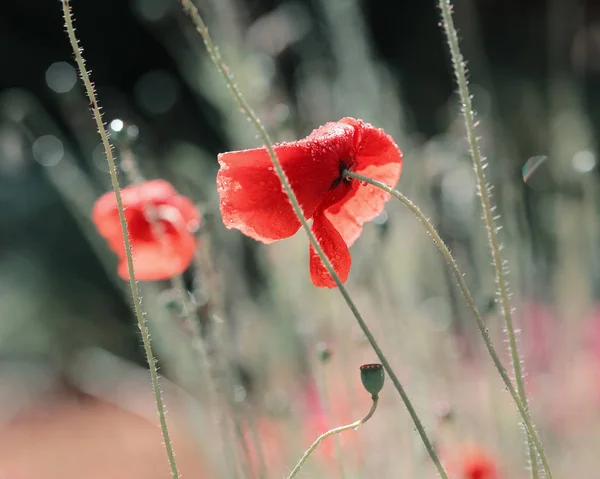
left=439, top=0, right=548, bottom=479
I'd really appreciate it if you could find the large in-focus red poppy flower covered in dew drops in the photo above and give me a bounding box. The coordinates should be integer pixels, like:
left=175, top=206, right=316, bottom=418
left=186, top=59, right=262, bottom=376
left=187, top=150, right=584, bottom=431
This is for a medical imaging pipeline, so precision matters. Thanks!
left=217, top=118, right=402, bottom=288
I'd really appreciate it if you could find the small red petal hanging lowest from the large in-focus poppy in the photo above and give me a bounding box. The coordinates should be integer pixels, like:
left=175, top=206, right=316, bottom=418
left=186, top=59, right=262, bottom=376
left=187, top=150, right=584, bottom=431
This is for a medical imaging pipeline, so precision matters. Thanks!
left=310, top=213, right=352, bottom=288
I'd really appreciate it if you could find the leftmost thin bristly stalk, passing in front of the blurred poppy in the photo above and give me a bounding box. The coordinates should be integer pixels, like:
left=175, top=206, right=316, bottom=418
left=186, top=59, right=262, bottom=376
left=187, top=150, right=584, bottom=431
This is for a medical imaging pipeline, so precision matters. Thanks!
left=62, top=0, right=179, bottom=479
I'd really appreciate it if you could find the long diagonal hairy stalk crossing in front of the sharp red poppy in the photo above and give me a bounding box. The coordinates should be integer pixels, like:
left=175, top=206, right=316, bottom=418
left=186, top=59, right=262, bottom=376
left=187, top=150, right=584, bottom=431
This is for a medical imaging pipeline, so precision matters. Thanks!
left=180, top=0, right=448, bottom=479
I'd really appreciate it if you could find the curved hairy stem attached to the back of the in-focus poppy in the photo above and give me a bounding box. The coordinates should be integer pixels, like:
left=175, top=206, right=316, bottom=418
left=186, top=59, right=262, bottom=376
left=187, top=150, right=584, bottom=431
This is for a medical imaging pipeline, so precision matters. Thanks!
left=344, top=171, right=552, bottom=479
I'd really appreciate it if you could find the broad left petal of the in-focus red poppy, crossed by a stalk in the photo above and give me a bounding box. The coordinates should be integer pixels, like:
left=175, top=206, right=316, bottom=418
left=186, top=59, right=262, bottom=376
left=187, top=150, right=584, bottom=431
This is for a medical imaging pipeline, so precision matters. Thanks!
left=217, top=122, right=354, bottom=243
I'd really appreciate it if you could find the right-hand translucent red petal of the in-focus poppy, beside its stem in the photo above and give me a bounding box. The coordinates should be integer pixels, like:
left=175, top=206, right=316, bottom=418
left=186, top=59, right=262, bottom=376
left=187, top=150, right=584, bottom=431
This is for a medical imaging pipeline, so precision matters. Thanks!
left=325, top=118, right=402, bottom=246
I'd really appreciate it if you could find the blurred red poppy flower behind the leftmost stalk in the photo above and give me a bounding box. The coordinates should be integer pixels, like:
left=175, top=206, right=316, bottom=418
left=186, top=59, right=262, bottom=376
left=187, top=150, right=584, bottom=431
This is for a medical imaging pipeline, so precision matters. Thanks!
left=92, top=180, right=200, bottom=281
